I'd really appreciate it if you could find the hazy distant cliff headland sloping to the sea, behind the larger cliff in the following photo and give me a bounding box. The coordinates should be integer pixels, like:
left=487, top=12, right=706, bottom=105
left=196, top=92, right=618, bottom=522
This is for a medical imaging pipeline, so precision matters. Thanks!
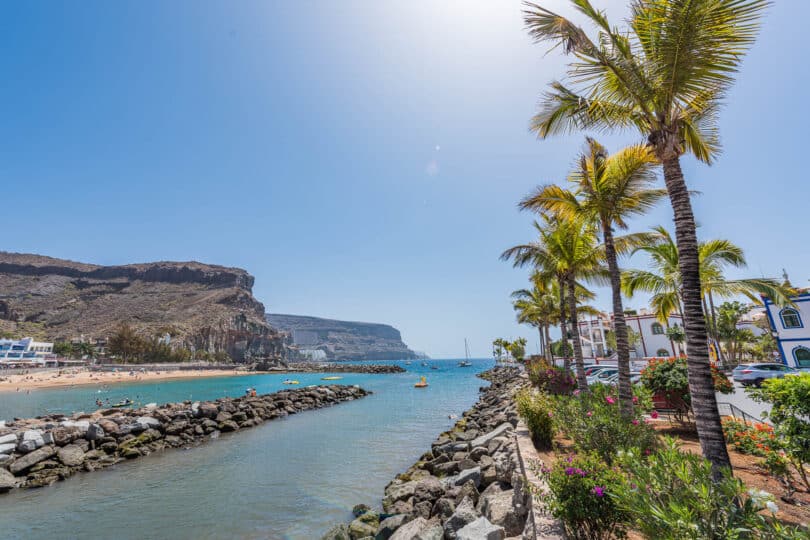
left=267, top=313, right=417, bottom=361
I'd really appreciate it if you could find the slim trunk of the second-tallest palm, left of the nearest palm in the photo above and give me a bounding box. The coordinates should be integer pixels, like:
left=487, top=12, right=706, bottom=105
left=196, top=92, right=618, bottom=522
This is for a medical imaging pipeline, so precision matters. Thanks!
left=602, top=222, right=633, bottom=416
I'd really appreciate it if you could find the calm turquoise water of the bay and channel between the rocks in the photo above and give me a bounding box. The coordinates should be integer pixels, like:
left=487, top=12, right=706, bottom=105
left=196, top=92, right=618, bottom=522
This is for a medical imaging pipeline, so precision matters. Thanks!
left=0, top=360, right=492, bottom=540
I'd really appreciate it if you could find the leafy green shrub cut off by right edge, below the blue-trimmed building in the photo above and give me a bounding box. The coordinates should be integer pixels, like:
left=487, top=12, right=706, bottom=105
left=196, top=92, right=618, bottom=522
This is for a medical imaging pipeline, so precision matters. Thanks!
left=748, top=373, right=810, bottom=489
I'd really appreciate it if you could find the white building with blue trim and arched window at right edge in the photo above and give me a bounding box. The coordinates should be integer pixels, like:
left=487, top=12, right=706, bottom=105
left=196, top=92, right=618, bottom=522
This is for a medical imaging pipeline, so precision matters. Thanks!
left=763, top=292, right=810, bottom=368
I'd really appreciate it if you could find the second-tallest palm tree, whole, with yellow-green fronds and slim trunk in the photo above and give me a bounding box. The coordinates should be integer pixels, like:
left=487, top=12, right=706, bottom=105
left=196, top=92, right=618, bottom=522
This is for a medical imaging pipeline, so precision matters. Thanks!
left=520, top=138, right=666, bottom=415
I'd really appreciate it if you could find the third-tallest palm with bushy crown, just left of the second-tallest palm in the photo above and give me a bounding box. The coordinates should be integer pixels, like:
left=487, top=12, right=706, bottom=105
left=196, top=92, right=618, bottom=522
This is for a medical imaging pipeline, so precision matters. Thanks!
left=501, top=217, right=606, bottom=391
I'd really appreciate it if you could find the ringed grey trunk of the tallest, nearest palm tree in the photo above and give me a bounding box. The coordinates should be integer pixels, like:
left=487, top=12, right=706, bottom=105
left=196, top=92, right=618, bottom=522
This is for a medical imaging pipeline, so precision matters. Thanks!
left=662, top=154, right=731, bottom=479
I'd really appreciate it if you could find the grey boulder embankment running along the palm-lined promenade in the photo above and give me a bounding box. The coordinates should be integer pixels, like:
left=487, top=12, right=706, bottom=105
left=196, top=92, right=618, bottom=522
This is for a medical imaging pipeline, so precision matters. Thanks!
left=322, top=367, right=531, bottom=540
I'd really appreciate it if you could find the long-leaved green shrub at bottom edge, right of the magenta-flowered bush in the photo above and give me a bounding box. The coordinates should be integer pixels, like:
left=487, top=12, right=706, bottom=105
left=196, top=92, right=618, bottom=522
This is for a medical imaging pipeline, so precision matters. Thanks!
left=610, top=438, right=803, bottom=540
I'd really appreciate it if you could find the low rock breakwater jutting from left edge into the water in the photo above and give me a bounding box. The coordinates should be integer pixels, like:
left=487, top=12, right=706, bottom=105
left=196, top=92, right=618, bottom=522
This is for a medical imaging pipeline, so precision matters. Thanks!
left=0, top=385, right=371, bottom=493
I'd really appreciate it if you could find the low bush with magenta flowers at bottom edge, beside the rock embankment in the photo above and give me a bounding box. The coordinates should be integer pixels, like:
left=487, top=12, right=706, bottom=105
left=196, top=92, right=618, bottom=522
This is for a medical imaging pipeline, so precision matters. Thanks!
left=541, top=454, right=627, bottom=540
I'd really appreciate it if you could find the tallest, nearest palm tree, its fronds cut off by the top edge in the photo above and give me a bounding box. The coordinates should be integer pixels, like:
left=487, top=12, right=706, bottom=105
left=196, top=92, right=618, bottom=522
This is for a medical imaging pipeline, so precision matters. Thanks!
left=524, top=0, right=768, bottom=475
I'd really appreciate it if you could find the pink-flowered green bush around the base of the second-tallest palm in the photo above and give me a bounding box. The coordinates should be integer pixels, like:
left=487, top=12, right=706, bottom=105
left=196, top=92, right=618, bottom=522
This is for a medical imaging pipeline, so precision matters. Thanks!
left=554, top=384, right=656, bottom=463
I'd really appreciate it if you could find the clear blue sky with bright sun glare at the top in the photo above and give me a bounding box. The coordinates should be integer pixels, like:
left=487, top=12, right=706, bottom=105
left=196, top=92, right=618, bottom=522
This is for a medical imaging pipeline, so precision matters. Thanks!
left=0, top=0, right=810, bottom=358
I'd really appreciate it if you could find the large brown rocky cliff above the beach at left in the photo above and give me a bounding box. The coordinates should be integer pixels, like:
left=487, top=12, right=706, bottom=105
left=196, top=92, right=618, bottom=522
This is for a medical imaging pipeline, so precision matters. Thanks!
left=0, top=252, right=284, bottom=361
